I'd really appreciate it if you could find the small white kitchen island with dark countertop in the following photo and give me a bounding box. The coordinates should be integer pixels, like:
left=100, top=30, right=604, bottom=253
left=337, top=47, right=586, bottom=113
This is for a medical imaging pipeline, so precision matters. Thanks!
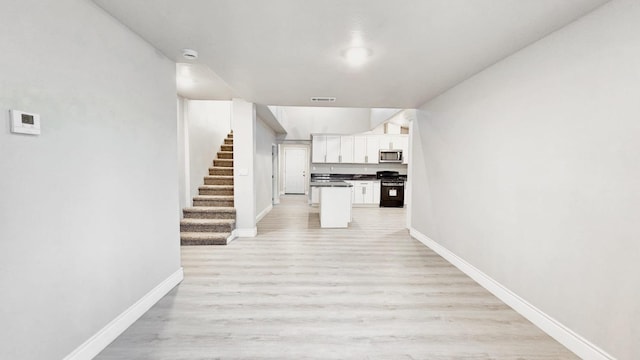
left=309, top=180, right=353, bottom=228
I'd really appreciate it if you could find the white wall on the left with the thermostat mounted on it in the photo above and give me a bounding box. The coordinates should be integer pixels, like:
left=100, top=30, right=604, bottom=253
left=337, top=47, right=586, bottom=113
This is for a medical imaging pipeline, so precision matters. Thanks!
left=0, top=0, right=180, bottom=360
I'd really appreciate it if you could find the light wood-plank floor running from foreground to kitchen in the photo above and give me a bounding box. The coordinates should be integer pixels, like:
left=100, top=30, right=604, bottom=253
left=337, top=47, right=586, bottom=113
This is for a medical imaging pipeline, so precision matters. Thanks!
left=97, top=196, right=576, bottom=360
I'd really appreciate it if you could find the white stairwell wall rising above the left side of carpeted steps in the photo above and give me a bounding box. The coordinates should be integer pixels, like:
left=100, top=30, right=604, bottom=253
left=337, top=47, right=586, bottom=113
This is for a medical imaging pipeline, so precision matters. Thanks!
left=184, top=100, right=231, bottom=206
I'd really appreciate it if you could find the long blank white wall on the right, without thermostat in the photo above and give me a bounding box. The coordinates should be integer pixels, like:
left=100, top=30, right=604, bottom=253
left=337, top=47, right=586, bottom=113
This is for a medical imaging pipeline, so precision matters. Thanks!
left=412, top=0, right=640, bottom=359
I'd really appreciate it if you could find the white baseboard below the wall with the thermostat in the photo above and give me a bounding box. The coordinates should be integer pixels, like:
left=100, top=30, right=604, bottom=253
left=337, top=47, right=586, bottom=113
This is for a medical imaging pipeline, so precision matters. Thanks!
left=64, top=268, right=184, bottom=360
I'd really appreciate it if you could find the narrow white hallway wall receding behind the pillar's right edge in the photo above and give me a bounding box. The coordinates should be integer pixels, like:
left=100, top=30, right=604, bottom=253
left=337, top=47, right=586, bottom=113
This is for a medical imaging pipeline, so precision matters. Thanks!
left=254, top=117, right=276, bottom=221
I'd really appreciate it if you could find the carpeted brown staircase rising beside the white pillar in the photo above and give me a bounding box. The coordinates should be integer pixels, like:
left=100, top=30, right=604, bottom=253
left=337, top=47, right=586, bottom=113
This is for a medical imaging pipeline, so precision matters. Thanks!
left=180, top=131, right=236, bottom=245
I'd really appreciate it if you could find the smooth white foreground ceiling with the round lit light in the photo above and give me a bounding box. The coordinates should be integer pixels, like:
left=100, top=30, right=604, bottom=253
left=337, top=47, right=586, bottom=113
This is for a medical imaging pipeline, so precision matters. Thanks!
left=94, top=0, right=608, bottom=108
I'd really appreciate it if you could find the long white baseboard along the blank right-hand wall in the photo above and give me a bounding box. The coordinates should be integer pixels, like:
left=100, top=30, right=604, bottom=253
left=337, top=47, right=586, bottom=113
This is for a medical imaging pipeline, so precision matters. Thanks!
left=409, top=228, right=614, bottom=360
